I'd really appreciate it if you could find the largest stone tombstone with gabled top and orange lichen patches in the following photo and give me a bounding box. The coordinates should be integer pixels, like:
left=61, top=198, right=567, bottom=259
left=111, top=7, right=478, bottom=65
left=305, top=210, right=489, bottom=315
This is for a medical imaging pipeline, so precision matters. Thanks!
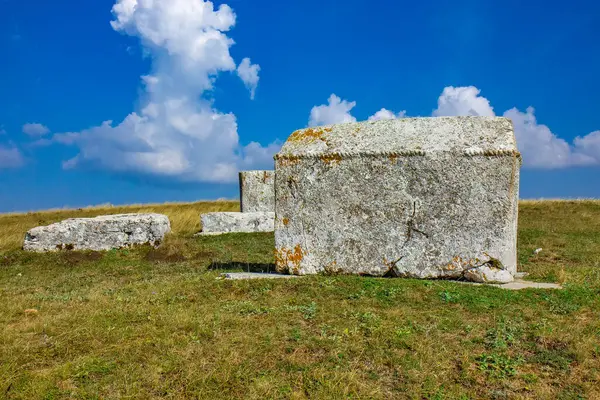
left=275, top=117, right=521, bottom=278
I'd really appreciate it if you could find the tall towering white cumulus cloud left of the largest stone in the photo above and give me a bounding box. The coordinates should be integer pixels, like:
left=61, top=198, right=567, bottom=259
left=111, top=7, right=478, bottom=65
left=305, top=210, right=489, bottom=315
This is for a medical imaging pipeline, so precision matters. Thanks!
left=45, top=0, right=279, bottom=182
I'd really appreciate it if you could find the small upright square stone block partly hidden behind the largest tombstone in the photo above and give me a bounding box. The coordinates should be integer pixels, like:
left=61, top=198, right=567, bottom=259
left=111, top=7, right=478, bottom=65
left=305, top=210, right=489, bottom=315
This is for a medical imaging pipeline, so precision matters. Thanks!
left=240, top=171, right=275, bottom=213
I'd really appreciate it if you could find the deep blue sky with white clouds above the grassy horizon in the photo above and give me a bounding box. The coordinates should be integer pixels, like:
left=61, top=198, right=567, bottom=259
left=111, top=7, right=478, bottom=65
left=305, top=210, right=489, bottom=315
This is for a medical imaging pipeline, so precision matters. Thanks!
left=0, top=0, right=600, bottom=212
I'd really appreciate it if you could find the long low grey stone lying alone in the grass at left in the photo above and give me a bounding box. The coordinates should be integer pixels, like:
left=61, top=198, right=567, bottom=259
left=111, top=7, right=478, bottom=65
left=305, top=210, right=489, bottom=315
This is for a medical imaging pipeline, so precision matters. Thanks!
left=23, top=214, right=171, bottom=252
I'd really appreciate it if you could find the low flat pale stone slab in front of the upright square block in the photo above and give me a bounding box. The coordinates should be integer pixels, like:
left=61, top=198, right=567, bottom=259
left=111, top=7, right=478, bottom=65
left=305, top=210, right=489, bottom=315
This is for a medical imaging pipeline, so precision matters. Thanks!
left=200, top=212, right=275, bottom=235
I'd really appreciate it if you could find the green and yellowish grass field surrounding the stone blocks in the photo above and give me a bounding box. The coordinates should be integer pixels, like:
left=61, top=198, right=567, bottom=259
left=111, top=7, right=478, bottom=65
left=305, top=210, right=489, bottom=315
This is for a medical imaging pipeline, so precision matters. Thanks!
left=0, top=201, right=600, bottom=399
